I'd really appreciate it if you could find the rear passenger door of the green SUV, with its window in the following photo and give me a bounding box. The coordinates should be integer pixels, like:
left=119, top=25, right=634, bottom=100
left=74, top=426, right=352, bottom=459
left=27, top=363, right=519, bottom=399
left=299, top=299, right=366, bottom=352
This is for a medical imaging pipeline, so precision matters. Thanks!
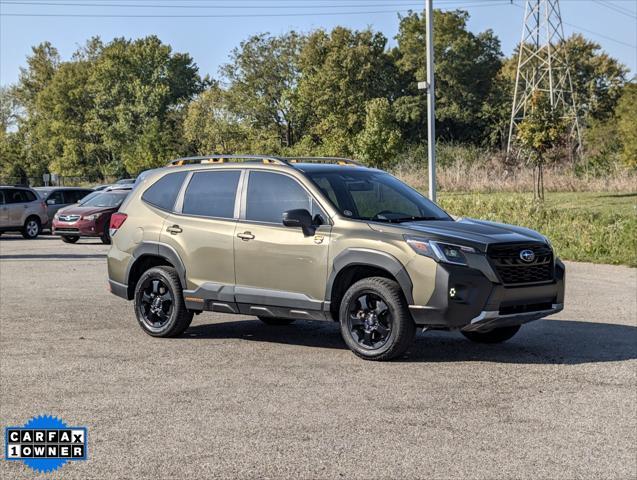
left=160, top=168, right=243, bottom=292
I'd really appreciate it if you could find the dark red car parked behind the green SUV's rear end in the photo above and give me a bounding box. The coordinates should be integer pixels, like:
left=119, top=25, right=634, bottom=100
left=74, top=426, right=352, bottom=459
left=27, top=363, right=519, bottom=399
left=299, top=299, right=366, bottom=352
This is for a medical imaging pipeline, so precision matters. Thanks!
left=52, top=190, right=130, bottom=244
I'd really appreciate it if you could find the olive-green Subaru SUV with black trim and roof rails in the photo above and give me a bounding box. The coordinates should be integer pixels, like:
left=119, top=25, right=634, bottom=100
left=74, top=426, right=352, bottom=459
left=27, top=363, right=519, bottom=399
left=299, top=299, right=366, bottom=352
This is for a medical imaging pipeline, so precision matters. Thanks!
left=108, top=155, right=565, bottom=360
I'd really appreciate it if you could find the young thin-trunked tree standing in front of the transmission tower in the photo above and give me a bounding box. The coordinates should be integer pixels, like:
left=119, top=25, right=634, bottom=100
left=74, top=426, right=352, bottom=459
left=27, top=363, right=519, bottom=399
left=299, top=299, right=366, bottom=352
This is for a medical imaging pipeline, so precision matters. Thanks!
left=517, top=91, right=566, bottom=200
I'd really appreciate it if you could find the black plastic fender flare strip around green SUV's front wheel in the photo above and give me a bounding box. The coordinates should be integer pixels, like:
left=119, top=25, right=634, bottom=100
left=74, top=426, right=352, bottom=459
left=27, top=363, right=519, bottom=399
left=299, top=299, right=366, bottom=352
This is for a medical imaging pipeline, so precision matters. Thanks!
left=325, top=248, right=414, bottom=305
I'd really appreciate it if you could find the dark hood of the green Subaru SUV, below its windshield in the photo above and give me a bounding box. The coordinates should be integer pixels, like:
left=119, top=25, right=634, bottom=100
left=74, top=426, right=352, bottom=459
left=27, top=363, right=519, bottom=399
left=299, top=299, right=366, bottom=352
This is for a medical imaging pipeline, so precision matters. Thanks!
left=370, top=218, right=547, bottom=252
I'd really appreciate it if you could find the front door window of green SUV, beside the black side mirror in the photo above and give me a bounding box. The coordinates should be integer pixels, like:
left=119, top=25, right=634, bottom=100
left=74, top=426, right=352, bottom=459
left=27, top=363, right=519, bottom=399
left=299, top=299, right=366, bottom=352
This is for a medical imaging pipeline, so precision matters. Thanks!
left=246, top=171, right=316, bottom=223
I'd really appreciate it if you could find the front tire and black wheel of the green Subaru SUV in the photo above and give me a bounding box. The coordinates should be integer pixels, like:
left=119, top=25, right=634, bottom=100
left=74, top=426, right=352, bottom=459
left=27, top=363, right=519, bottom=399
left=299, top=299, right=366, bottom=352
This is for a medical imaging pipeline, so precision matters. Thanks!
left=339, top=277, right=416, bottom=361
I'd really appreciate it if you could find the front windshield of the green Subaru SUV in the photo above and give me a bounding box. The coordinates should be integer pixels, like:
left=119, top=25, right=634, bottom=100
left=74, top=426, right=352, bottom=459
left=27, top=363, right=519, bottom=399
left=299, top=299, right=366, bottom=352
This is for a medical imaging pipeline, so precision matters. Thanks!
left=307, top=169, right=451, bottom=223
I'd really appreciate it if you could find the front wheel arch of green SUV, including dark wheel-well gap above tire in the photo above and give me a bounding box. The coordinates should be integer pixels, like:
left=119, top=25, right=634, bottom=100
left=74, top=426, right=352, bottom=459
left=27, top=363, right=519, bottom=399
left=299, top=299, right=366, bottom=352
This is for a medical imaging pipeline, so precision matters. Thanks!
left=325, top=248, right=414, bottom=319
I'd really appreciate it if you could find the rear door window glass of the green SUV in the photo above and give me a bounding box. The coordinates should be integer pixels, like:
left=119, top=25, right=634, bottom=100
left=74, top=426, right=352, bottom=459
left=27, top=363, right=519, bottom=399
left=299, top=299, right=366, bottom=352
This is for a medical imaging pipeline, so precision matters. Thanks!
left=181, top=170, right=241, bottom=218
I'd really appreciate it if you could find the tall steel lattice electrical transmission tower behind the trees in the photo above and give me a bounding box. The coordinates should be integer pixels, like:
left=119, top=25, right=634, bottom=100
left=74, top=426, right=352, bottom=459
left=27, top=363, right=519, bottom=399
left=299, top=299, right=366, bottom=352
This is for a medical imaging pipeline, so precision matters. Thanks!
left=507, top=0, right=581, bottom=152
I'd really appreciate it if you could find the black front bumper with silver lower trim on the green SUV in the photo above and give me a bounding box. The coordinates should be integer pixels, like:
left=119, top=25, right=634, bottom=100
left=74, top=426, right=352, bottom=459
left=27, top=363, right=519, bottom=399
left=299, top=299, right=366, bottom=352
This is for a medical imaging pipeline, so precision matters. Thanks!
left=409, top=260, right=565, bottom=331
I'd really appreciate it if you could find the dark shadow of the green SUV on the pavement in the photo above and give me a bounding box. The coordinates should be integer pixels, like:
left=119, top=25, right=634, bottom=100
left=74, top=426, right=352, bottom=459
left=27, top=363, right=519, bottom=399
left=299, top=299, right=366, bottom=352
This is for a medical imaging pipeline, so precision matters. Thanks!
left=181, top=320, right=637, bottom=365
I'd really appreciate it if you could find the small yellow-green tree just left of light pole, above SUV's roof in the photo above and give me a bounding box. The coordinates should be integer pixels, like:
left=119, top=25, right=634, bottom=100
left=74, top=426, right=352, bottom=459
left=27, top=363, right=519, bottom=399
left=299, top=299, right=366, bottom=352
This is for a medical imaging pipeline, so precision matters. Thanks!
left=355, top=98, right=401, bottom=169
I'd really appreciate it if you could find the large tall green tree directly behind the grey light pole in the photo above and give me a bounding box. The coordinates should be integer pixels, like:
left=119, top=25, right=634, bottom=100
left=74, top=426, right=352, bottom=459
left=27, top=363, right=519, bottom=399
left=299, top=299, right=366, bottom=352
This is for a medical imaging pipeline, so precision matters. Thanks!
left=394, top=10, right=510, bottom=143
